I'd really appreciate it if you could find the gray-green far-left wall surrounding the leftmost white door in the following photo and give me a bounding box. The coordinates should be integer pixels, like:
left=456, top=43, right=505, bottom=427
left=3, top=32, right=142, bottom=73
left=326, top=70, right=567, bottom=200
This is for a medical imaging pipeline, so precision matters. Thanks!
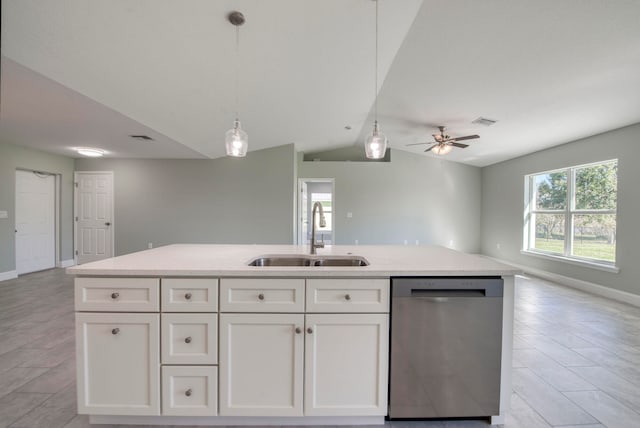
left=0, top=143, right=73, bottom=273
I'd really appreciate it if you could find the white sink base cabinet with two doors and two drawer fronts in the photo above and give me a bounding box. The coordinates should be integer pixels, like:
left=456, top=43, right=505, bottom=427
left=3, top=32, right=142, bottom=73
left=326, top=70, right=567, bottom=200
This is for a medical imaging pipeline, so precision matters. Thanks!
left=220, top=278, right=389, bottom=416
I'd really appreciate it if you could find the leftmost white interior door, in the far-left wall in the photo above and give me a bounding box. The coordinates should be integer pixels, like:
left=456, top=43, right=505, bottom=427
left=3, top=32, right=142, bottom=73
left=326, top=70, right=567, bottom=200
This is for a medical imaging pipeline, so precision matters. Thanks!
left=16, top=170, right=56, bottom=275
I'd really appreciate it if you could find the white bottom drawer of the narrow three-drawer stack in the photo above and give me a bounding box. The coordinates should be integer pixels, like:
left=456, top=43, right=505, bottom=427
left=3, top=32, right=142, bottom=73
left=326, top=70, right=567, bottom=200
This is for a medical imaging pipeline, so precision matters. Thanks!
left=162, top=366, right=218, bottom=416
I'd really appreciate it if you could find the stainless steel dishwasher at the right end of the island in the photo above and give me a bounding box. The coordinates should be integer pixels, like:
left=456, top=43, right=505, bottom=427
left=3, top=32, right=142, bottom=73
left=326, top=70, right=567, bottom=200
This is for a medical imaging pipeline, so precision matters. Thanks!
left=389, top=277, right=503, bottom=419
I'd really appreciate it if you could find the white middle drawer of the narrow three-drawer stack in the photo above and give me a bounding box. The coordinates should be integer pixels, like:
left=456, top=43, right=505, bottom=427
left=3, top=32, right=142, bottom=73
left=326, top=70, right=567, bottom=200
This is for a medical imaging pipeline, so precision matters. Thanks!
left=161, top=314, right=218, bottom=364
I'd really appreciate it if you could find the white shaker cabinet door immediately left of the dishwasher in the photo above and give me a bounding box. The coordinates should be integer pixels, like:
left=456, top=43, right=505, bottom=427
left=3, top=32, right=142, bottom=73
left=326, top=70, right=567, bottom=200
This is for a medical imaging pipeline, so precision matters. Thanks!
left=304, top=314, right=389, bottom=416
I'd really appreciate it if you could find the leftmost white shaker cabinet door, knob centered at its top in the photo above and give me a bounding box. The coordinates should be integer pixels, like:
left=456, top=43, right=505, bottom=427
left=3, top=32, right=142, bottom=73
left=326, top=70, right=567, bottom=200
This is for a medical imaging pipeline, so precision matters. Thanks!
left=76, top=313, right=160, bottom=415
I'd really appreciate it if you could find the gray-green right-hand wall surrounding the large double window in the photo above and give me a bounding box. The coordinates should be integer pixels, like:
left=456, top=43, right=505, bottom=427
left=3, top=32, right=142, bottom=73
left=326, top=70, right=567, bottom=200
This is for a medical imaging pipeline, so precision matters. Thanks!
left=482, top=124, right=640, bottom=294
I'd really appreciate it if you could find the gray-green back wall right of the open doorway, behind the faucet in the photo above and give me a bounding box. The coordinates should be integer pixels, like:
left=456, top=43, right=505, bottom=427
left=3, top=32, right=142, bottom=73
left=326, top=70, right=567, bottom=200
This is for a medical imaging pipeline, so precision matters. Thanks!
left=298, top=150, right=481, bottom=252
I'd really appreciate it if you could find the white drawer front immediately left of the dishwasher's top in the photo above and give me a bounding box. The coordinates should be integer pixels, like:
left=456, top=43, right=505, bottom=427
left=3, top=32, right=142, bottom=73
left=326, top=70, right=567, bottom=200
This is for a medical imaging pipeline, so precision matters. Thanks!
left=306, top=279, right=389, bottom=313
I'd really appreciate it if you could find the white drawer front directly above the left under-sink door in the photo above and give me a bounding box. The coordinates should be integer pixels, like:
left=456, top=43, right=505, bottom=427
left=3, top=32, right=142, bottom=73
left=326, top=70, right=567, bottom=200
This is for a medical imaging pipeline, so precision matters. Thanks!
left=220, top=278, right=304, bottom=312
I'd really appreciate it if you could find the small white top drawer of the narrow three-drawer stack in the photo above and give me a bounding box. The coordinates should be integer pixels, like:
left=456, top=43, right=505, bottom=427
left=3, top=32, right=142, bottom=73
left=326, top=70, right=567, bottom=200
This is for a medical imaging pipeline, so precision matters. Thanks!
left=162, top=278, right=218, bottom=312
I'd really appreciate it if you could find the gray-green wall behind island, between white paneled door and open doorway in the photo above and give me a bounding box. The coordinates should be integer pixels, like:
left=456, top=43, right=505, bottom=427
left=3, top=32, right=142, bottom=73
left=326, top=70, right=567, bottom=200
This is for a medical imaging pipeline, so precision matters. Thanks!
left=76, top=144, right=295, bottom=255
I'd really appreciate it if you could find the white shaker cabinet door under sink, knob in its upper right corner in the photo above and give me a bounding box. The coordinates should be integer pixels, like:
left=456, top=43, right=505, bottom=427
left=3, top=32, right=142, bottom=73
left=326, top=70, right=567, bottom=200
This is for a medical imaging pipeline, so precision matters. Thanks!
left=219, top=314, right=304, bottom=416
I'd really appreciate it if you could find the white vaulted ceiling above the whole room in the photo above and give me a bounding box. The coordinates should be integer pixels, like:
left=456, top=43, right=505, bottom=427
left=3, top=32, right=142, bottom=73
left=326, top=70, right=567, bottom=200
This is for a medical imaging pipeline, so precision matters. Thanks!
left=0, top=0, right=640, bottom=166
